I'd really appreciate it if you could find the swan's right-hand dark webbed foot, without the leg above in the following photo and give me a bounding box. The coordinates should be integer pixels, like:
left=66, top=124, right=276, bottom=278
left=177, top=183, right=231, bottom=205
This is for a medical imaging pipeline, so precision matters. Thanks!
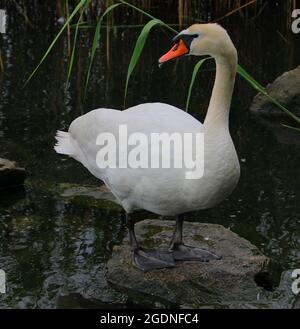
left=170, top=244, right=222, bottom=262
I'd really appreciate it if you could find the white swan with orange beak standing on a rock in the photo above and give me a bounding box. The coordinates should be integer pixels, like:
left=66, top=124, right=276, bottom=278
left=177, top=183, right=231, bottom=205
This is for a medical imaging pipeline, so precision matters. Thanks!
left=55, top=24, right=240, bottom=271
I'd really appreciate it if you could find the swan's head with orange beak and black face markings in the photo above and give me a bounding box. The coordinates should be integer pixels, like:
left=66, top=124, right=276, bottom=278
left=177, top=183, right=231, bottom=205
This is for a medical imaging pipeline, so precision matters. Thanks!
left=159, top=23, right=237, bottom=64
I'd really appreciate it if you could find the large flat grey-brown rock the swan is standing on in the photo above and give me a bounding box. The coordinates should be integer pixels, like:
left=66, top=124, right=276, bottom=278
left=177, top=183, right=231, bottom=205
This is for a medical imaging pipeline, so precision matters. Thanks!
left=107, top=220, right=280, bottom=308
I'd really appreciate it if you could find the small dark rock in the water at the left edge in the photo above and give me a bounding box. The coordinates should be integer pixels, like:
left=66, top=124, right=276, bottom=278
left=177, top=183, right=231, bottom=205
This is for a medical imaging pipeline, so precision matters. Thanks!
left=0, top=158, right=26, bottom=189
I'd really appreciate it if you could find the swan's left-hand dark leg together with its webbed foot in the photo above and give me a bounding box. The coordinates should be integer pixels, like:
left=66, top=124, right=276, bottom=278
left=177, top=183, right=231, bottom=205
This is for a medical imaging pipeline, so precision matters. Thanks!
left=126, top=214, right=175, bottom=272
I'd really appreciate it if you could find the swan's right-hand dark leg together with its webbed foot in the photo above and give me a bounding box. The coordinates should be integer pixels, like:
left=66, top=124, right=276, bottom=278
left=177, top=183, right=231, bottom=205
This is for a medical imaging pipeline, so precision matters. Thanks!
left=169, top=215, right=222, bottom=262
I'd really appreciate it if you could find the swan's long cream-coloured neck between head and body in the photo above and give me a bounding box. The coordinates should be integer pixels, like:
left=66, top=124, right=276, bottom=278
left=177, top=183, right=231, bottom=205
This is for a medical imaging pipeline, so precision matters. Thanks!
left=204, top=48, right=237, bottom=129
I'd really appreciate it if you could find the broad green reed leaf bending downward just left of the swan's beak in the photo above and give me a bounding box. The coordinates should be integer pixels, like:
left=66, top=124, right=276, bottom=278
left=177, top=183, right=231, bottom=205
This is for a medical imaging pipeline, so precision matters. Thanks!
left=124, top=19, right=164, bottom=106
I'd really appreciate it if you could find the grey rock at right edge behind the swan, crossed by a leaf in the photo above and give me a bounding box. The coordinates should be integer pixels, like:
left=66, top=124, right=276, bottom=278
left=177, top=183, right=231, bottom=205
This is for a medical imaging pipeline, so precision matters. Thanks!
left=250, top=66, right=300, bottom=118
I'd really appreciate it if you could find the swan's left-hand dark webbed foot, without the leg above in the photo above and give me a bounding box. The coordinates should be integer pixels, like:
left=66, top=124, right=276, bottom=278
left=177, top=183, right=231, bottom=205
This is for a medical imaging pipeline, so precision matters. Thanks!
left=133, top=248, right=175, bottom=272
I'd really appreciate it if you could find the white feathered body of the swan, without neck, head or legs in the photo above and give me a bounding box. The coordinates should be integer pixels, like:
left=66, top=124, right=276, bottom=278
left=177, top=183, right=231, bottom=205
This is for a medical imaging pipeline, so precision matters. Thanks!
left=55, top=103, right=238, bottom=215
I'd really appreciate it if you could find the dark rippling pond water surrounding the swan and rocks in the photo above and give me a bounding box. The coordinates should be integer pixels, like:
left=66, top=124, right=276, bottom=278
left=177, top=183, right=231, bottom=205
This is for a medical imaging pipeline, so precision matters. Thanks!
left=0, top=5, right=300, bottom=308
